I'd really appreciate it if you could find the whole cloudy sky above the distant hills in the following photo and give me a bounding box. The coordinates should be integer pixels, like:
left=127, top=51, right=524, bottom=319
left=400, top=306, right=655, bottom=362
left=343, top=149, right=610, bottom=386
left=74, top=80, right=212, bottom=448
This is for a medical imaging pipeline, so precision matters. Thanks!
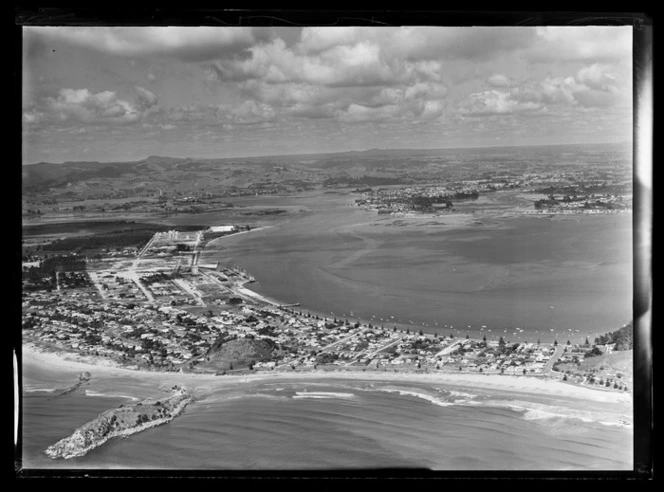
left=22, top=26, right=633, bottom=164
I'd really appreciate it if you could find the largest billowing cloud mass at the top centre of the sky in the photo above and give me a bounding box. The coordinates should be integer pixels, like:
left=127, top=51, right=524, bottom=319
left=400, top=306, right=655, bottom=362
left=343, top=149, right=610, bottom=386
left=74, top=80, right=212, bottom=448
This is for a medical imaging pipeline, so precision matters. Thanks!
left=209, top=28, right=448, bottom=122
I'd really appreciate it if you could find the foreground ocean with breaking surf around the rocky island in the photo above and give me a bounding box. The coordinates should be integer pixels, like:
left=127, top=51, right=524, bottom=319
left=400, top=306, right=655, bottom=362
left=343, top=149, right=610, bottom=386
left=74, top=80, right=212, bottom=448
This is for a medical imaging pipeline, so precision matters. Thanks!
left=22, top=362, right=633, bottom=471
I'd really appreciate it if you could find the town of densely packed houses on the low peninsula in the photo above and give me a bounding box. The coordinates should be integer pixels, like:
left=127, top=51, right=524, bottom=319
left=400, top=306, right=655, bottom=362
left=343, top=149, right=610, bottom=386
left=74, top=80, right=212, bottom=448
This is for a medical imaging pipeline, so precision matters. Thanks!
left=22, top=226, right=631, bottom=391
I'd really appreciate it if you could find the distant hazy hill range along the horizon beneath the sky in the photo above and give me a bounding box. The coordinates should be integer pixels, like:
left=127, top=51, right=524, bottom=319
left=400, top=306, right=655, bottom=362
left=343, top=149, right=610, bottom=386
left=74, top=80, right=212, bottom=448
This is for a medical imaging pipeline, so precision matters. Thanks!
left=22, top=140, right=631, bottom=194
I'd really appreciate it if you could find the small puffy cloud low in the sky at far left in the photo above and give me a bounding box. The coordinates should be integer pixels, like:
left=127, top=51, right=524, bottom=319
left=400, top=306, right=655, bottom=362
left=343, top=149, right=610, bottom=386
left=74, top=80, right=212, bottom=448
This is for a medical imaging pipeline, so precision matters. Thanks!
left=44, top=86, right=157, bottom=123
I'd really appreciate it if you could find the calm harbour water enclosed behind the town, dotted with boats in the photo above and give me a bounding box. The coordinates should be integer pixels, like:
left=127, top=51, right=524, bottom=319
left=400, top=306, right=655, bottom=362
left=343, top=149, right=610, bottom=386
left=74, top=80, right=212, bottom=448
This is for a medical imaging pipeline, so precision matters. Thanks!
left=204, top=194, right=632, bottom=342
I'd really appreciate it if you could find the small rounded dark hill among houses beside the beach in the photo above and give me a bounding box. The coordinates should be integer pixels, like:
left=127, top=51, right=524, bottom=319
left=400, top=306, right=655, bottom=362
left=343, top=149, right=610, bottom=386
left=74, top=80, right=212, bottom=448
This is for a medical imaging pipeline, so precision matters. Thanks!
left=198, top=338, right=277, bottom=369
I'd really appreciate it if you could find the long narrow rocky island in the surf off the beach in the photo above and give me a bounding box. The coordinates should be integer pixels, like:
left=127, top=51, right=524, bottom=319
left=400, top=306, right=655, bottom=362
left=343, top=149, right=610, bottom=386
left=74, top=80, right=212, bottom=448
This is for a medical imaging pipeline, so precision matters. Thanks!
left=46, top=386, right=191, bottom=459
